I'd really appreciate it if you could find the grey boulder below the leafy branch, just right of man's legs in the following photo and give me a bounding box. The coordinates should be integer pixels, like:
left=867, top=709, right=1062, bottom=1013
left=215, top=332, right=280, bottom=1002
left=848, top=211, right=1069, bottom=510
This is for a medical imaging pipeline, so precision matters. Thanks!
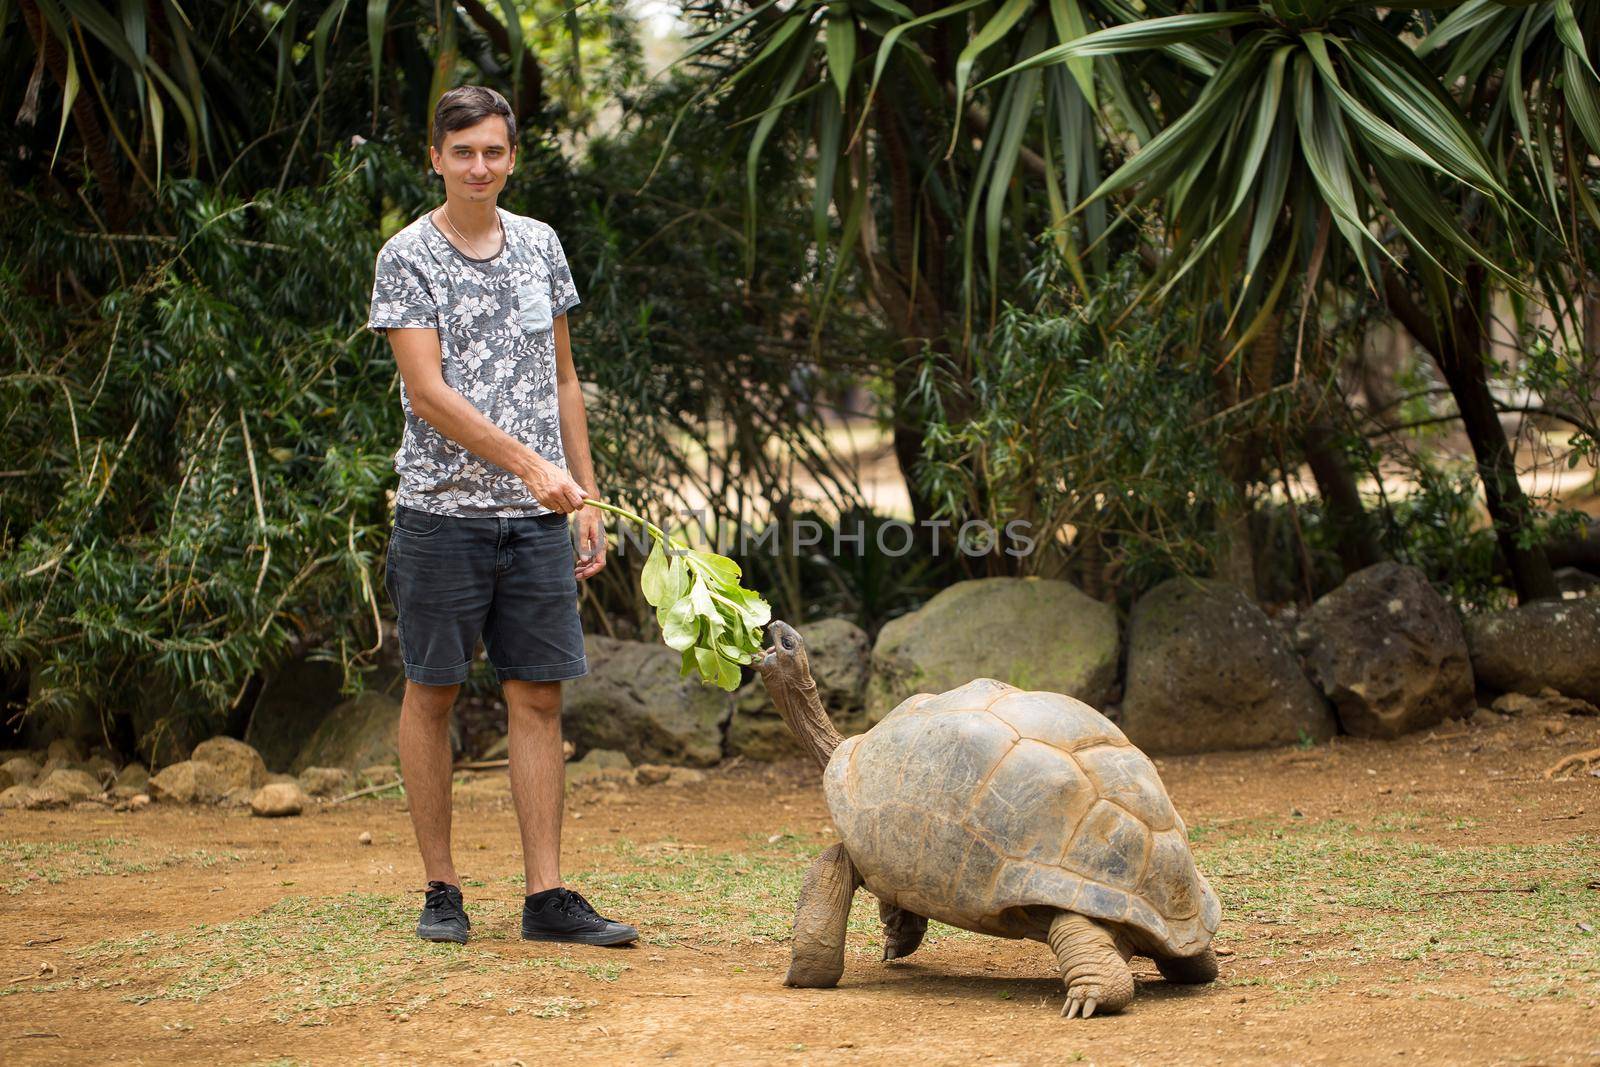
left=562, top=635, right=731, bottom=765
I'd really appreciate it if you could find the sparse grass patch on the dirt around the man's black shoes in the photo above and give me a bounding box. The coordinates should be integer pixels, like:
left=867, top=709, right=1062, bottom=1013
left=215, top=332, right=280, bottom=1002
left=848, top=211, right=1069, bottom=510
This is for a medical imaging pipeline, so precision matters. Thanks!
left=75, top=893, right=627, bottom=1025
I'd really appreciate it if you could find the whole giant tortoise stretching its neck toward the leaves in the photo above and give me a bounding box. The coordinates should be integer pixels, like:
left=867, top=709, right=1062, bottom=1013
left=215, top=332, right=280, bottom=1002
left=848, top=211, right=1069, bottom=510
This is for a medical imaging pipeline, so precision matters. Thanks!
left=757, top=621, right=1221, bottom=1019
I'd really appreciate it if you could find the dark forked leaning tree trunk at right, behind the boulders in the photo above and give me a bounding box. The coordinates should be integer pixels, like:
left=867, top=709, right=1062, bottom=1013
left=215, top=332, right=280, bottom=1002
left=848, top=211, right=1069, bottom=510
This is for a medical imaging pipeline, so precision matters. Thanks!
left=1384, top=264, right=1560, bottom=603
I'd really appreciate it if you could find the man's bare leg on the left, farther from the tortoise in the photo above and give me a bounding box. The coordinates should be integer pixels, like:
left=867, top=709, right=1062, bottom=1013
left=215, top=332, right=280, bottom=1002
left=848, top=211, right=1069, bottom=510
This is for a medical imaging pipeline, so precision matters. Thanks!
left=400, top=681, right=461, bottom=886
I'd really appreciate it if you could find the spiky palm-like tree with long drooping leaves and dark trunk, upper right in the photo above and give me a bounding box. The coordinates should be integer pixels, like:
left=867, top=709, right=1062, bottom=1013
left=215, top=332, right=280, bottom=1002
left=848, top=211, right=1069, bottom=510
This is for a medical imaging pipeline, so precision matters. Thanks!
left=698, top=0, right=1600, bottom=598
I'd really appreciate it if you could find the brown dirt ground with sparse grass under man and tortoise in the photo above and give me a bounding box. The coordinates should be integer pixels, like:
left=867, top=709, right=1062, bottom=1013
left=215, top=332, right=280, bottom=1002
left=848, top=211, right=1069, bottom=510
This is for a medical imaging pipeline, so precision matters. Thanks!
left=0, top=718, right=1600, bottom=1065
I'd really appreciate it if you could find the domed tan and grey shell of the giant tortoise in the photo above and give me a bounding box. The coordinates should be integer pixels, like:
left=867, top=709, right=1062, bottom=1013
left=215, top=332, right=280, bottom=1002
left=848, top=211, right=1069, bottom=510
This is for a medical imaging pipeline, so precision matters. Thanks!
left=824, top=678, right=1221, bottom=957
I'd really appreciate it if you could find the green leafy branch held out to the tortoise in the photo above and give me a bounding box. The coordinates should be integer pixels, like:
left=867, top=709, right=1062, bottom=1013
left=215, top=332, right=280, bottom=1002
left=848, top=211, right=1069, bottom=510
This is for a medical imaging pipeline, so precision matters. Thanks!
left=584, top=501, right=773, bottom=693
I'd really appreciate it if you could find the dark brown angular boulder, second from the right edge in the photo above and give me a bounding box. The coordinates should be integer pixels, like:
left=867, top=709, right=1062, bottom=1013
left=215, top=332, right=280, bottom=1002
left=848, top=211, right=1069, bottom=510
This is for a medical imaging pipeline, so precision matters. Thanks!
left=1294, top=563, right=1477, bottom=737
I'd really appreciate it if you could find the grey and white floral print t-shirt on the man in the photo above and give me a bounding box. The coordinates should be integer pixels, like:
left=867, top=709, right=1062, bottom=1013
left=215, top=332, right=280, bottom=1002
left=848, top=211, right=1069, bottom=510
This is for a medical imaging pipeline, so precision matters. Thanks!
left=366, top=208, right=578, bottom=518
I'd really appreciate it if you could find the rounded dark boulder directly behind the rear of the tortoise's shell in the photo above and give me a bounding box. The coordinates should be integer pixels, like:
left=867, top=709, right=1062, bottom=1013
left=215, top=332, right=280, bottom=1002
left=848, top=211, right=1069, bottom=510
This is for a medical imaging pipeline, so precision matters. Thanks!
left=1118, top=577, right=1334, bottom=753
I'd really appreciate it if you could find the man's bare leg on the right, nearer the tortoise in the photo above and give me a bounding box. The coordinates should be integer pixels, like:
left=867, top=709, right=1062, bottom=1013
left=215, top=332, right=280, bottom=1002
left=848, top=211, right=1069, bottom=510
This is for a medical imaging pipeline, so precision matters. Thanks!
left=502, top=681, right=566, bottom=894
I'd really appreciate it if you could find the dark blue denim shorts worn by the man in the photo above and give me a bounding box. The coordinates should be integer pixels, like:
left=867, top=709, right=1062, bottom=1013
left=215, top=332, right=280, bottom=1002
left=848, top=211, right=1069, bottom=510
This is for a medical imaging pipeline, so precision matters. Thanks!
left=384, top=506, right=589, bottom=685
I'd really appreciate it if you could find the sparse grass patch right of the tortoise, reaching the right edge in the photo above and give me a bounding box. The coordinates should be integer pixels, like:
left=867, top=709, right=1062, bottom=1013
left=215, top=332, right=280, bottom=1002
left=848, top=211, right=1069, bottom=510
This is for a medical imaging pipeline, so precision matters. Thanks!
left=1195, top=813, right=1600, bottom=997
